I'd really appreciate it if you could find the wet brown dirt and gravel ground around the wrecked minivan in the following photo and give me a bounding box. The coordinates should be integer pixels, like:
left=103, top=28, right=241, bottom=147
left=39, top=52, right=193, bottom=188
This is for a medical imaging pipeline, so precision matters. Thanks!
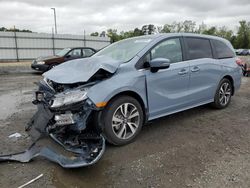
left=0, top=74, right=250, bottom=188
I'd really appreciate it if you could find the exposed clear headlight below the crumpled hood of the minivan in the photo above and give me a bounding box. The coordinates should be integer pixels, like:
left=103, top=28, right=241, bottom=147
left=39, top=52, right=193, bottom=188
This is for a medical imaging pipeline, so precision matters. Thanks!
left=51, top=89, right=87, bottom=108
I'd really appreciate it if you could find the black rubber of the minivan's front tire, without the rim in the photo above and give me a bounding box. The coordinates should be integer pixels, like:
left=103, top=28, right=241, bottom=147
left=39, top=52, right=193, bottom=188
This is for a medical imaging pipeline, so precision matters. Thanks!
left=102, top=96, right=144, bottom=145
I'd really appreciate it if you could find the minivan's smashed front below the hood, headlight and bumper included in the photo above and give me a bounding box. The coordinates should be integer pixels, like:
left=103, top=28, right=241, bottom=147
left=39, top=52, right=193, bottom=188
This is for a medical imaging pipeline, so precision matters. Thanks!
left=0, top=79, right=105, bottom=168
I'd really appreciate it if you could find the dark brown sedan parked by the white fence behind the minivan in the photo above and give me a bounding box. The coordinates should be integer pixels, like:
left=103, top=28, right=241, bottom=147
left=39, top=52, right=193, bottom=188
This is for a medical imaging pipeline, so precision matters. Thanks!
left=31, top=47, right=96, bottom=72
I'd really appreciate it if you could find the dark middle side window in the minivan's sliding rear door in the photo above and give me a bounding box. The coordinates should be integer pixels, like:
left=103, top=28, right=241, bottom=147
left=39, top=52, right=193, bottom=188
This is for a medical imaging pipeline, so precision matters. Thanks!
left=186, top=37, right=213, bottom=60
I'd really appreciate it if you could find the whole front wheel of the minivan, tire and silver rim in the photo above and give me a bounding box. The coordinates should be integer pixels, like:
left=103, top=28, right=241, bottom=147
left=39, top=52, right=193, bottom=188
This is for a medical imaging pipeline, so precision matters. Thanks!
left=102, top=96, right=144, bottom=146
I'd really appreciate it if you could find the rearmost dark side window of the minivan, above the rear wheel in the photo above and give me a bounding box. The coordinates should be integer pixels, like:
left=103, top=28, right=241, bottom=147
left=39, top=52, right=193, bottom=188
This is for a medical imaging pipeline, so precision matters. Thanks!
left=213, top=40, right=234, bottom=59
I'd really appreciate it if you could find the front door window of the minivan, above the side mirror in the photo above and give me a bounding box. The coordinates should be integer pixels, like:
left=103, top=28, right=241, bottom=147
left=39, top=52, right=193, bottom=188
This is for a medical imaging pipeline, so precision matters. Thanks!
left=151, top=38, right=182, bottom=63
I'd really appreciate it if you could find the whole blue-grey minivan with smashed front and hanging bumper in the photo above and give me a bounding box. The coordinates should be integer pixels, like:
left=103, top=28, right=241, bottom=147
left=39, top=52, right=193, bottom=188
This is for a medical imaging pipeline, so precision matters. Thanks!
left=0, top=33, right=241, bottom=168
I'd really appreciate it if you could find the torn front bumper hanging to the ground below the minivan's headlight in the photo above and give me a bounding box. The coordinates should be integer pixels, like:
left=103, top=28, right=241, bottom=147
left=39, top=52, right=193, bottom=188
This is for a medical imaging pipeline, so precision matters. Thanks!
left=0, top=99, right=105, bottom=168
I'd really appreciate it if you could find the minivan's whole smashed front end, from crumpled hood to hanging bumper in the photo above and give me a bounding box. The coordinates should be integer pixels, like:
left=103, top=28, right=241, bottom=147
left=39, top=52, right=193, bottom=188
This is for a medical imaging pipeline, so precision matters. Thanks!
left=0, top=56, right=121, bottom=168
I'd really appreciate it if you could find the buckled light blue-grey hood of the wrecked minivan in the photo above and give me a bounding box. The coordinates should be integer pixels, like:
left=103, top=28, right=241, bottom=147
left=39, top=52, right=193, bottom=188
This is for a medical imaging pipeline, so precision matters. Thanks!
left=43, top=56, right=121, bottom=84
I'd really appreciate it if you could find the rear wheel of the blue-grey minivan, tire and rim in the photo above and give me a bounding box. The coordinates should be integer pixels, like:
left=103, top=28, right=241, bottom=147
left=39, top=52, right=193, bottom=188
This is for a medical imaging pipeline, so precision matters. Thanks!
left=212, top=78, right=233, bottom=109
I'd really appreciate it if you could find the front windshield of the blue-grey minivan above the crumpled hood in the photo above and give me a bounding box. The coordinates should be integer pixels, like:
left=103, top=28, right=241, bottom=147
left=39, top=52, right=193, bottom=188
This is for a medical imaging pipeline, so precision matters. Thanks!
left=93, top=37, right=152, bottom=62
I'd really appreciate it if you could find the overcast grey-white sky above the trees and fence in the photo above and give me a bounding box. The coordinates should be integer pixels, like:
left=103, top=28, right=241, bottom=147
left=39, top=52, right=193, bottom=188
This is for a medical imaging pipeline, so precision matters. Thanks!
left=0, top=0, right=250, bottom=34
